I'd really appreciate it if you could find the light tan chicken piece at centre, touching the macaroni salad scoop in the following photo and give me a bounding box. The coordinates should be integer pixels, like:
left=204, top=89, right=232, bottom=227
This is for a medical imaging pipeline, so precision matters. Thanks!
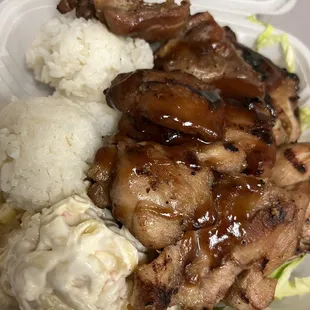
left=88, top=141, right=246, bottom=249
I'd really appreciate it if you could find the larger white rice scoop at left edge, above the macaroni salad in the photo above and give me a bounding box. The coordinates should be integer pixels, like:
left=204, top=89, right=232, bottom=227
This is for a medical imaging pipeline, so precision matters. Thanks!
left=0, top=97, right=118, bottom=211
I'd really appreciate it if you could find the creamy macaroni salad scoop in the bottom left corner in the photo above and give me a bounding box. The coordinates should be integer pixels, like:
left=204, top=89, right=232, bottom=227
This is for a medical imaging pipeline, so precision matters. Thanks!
left=0, top=196, right=144, bottom=310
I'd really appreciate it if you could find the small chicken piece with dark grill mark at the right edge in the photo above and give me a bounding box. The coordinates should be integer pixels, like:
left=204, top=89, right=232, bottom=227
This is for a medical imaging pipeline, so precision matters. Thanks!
left=271, top=143, right=310, bottom=187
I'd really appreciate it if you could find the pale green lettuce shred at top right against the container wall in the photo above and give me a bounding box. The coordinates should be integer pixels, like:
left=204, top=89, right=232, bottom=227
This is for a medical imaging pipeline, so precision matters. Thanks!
left=248, top=15, right=296, bottom=72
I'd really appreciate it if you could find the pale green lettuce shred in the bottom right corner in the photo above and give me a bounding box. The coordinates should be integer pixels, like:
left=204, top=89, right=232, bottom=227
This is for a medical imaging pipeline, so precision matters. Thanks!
left=270, top=257, right=310, bottom=299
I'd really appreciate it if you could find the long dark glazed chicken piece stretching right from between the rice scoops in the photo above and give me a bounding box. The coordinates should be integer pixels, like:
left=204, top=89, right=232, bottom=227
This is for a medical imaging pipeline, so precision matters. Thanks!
left=105, top=70, right=276, bottom=176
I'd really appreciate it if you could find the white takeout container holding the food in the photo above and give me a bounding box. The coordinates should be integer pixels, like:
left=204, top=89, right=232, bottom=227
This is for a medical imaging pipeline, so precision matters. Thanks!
left=0, top=0, right=310, bottom=310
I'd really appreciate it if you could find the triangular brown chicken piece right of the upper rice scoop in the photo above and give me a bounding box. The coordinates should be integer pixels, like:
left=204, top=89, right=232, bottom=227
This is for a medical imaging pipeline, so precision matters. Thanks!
left=155, top=13, right=265, bottom=98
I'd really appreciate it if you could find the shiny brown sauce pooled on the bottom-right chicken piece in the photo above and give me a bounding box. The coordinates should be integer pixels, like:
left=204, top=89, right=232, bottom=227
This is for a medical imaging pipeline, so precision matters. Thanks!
left=203, top=175, right=264, bottom=266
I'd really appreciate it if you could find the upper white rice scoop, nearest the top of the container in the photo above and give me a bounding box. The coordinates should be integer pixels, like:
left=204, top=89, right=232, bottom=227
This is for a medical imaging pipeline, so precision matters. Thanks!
left=26, top=14, right=153, bottom=101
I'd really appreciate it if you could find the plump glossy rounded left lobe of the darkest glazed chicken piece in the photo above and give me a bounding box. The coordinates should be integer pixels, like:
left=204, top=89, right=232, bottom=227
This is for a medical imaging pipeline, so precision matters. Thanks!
left=105, top=70, right=225, bottom=142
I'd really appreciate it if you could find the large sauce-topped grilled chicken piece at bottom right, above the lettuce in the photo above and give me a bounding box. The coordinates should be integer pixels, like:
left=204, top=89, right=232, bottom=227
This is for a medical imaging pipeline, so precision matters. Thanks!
left=132, top=175, right=307, bottom=309
